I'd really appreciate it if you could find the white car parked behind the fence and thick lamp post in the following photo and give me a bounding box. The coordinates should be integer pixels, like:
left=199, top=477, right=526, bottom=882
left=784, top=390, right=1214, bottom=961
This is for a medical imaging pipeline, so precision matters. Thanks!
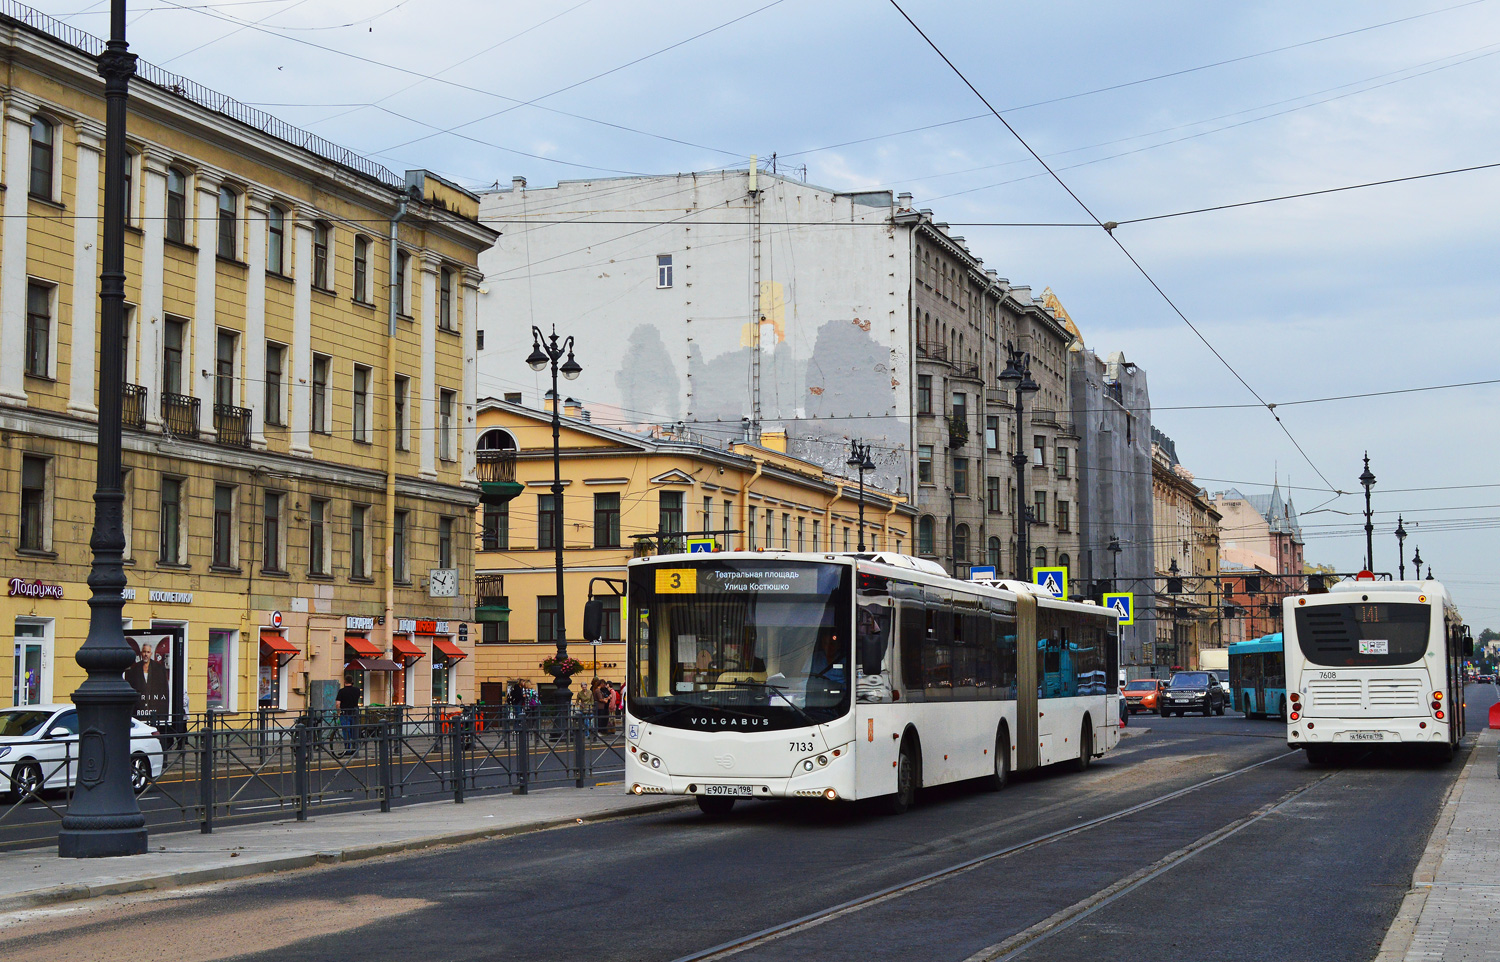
left=0, top=705, right=162, bottom=800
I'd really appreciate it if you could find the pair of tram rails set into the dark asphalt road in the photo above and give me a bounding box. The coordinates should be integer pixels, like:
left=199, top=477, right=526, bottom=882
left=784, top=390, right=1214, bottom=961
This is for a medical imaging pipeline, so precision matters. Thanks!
left=674, top=750, right=1302, bottom=962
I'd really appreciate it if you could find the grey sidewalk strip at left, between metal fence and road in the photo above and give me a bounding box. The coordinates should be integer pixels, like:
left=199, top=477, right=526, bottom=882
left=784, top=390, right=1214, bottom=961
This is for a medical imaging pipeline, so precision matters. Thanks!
left=0, top=785, right=692, bottom=912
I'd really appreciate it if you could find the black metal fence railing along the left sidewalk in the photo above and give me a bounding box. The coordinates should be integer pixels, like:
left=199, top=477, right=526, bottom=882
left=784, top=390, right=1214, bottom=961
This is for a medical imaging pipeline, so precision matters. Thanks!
left=0, top=707, right=626, bottom=846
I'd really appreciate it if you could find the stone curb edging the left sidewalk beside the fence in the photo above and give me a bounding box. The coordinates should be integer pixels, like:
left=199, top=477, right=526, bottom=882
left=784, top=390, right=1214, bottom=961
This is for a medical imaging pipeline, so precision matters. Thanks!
left=0, top=797, right=695, bottom=912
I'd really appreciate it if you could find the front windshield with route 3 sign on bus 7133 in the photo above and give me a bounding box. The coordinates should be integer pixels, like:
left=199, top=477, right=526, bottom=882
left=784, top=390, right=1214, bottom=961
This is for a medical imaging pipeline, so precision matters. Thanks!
left=627, top=560, right=855, bottom=731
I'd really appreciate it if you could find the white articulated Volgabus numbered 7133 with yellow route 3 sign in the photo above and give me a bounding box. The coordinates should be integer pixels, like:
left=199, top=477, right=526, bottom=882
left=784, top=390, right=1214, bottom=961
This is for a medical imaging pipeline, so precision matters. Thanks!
left=606, top=552, right=1119, bottom=815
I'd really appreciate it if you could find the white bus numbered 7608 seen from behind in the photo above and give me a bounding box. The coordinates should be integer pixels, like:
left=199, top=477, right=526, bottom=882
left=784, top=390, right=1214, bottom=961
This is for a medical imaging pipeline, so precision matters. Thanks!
left=1284, top=579, right=1473, bottom=764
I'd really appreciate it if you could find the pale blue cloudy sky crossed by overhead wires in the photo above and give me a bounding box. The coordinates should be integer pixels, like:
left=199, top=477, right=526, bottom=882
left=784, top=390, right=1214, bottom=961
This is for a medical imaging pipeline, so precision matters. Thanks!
left=36, top=0, right=1500, bottom=627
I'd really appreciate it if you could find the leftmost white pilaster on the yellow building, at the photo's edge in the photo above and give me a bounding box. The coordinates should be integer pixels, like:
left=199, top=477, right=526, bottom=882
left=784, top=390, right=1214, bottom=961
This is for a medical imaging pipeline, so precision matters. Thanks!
left=0, top=90, right=39, bottom=404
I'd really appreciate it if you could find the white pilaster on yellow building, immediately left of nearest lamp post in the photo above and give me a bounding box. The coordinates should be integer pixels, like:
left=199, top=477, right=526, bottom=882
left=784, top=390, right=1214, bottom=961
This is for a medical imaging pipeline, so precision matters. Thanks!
left=68, top=120, right=104, bottom=417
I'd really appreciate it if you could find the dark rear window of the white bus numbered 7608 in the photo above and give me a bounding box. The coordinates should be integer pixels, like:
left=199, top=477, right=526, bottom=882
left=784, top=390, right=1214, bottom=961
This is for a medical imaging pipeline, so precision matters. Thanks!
left=1298, top=602, right=1433, bottom=668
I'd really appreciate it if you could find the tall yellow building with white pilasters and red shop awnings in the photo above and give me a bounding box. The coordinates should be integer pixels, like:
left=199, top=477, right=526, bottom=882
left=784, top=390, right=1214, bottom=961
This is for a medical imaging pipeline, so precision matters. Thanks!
left=0, top=14, right=497, bottom=716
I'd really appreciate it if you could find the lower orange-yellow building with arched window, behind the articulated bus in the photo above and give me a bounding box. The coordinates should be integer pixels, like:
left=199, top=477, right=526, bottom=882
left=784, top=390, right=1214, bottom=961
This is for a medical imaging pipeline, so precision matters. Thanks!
left=476, top=395, right=917, bottom=701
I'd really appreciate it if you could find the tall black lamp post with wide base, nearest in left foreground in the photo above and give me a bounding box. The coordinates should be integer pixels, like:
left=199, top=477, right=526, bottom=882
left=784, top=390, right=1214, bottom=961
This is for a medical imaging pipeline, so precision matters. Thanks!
left=60, top=0, right=146, bottom=858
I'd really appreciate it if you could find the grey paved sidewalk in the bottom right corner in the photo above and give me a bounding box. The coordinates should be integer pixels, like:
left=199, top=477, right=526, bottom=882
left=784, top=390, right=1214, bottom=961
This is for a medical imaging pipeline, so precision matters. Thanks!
left=1376, top=728, right=1500, bottom=962
